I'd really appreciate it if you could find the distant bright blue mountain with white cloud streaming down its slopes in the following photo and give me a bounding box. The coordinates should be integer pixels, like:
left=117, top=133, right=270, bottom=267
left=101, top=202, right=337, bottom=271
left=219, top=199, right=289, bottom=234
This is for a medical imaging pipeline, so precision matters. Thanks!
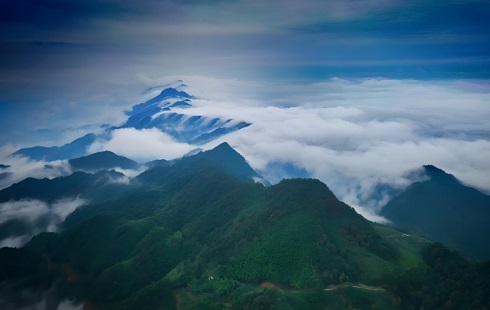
left=12, top=81, right=251, bottom=161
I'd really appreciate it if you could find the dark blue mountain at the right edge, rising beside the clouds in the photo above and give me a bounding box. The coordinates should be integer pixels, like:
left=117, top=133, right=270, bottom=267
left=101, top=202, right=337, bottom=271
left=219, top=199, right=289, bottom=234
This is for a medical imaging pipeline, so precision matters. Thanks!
left=380, top=165, right=490, bottom=259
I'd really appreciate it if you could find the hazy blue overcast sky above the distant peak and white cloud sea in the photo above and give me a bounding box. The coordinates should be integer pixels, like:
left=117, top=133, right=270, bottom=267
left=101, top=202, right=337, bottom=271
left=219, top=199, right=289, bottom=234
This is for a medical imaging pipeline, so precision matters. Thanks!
left=0, top=0, right=490, bottom=144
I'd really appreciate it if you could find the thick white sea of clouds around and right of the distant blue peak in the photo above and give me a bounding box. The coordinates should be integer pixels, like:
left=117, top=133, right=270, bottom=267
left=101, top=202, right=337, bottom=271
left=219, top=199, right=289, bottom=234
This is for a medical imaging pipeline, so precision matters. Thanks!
left=100, top=77, right=490, bottom=219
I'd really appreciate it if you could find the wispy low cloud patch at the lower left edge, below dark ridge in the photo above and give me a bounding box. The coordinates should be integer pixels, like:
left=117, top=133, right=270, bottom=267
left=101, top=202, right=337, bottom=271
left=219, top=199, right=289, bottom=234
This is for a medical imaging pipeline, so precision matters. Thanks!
left=0, top=197, right=86, bottom=248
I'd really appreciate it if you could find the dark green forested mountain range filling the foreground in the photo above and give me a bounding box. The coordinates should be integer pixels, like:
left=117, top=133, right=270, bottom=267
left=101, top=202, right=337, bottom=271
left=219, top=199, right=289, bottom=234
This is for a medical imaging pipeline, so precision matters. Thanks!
left=0, top=143, right=490, bottom=309
